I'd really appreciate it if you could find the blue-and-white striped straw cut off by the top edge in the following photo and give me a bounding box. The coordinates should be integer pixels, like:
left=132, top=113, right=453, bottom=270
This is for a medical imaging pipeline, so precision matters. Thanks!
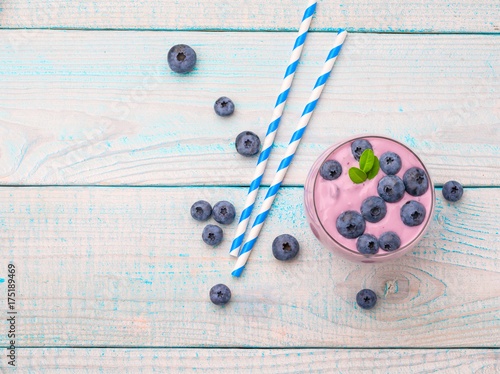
left=229, top=0, right=317, bottom=257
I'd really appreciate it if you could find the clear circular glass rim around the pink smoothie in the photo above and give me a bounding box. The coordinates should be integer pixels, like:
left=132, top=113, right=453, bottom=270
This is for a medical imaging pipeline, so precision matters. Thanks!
left=312, top=134, right=436, bottom=259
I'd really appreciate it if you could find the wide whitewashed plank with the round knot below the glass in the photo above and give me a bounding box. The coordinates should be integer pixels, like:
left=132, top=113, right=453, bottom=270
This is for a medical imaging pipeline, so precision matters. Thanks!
left=0, top=187, right=500, bottom=348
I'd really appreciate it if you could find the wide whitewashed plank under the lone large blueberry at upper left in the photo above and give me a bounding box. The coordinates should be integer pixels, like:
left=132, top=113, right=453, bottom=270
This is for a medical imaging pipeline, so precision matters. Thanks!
left=0, top=30, right=500, bottom=186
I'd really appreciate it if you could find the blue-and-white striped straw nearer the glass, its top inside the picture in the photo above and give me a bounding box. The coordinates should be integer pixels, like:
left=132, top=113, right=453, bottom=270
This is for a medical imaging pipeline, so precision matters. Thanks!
left=232, top=30, right=347, bottom=277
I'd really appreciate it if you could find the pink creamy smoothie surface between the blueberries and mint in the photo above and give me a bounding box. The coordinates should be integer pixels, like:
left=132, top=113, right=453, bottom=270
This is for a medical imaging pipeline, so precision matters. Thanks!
left=314, top=137, right=433, bottom=254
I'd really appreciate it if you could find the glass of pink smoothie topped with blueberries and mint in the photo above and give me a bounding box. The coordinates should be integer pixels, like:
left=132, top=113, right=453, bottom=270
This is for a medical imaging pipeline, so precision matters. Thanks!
left=305, top=136, right=435, bottom=262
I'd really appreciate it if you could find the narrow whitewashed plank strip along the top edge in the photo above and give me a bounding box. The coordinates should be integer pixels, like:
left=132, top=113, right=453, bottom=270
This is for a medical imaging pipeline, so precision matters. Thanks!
left=0, top=0, right=500, bottom=33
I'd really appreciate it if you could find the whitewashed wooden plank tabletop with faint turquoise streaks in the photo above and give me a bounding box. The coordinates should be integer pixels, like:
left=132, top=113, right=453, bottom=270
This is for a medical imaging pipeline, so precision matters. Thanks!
left=0, top=0, right=500, bottom=374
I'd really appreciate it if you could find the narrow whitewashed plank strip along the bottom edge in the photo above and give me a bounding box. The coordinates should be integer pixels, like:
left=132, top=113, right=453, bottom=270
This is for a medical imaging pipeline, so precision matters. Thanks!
left=10, top=348, right=500, bottom=374
